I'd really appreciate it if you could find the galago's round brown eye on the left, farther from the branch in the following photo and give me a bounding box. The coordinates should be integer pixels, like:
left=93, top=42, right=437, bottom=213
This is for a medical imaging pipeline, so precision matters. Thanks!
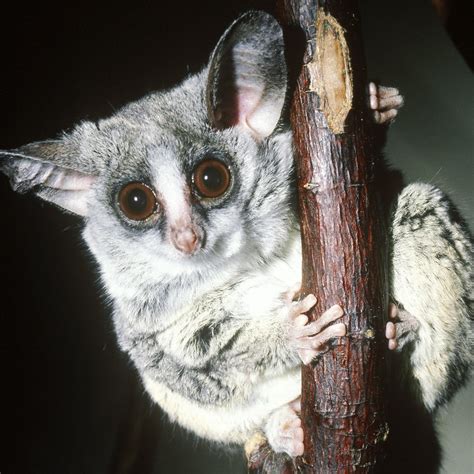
left=118, top=182, right=158, bottom=221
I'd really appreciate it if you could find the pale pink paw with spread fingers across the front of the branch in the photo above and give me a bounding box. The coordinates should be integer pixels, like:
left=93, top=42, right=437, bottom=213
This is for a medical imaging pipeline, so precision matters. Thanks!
left=289, top=286, right=346, bottom=364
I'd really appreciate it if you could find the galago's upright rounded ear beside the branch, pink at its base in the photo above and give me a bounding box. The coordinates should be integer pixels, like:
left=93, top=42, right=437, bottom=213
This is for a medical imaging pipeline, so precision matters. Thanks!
left=206, top=11, right=287, bottom=139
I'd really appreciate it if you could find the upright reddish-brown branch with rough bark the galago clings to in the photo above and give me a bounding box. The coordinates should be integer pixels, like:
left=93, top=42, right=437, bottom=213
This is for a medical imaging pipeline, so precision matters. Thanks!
left=252, top=0, right=388, bottom=473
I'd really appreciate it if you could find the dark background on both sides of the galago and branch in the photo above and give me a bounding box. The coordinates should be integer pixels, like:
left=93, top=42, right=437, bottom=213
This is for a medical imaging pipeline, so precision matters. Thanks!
left=0, top=0, right=474, bottom=474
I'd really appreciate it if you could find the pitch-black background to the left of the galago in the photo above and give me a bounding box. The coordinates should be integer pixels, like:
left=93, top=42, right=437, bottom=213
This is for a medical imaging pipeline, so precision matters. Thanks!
left=0, top=1, right=472, bottom=474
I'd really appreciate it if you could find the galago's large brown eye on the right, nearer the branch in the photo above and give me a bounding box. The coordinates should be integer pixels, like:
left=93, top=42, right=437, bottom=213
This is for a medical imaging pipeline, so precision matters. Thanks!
left=193, top=159, right=230, bottom=198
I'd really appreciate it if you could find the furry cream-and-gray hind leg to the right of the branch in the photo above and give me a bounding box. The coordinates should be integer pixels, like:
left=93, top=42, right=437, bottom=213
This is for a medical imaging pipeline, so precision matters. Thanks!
left=392, top=183, right=474, bottom=411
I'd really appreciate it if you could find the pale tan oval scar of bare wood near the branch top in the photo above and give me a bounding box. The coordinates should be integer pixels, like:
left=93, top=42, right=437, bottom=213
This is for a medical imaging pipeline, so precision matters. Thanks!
left=306, top=8, right=353, bottom=133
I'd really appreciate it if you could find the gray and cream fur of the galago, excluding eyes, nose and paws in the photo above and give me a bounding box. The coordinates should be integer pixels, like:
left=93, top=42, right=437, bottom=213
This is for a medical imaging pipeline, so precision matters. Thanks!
left=0, top=12, right=472, bottom=454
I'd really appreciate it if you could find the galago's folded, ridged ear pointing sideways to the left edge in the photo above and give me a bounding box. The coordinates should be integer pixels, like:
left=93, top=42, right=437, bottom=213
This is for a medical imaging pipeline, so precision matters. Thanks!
left=0, top=137, right=96, bottom=216
